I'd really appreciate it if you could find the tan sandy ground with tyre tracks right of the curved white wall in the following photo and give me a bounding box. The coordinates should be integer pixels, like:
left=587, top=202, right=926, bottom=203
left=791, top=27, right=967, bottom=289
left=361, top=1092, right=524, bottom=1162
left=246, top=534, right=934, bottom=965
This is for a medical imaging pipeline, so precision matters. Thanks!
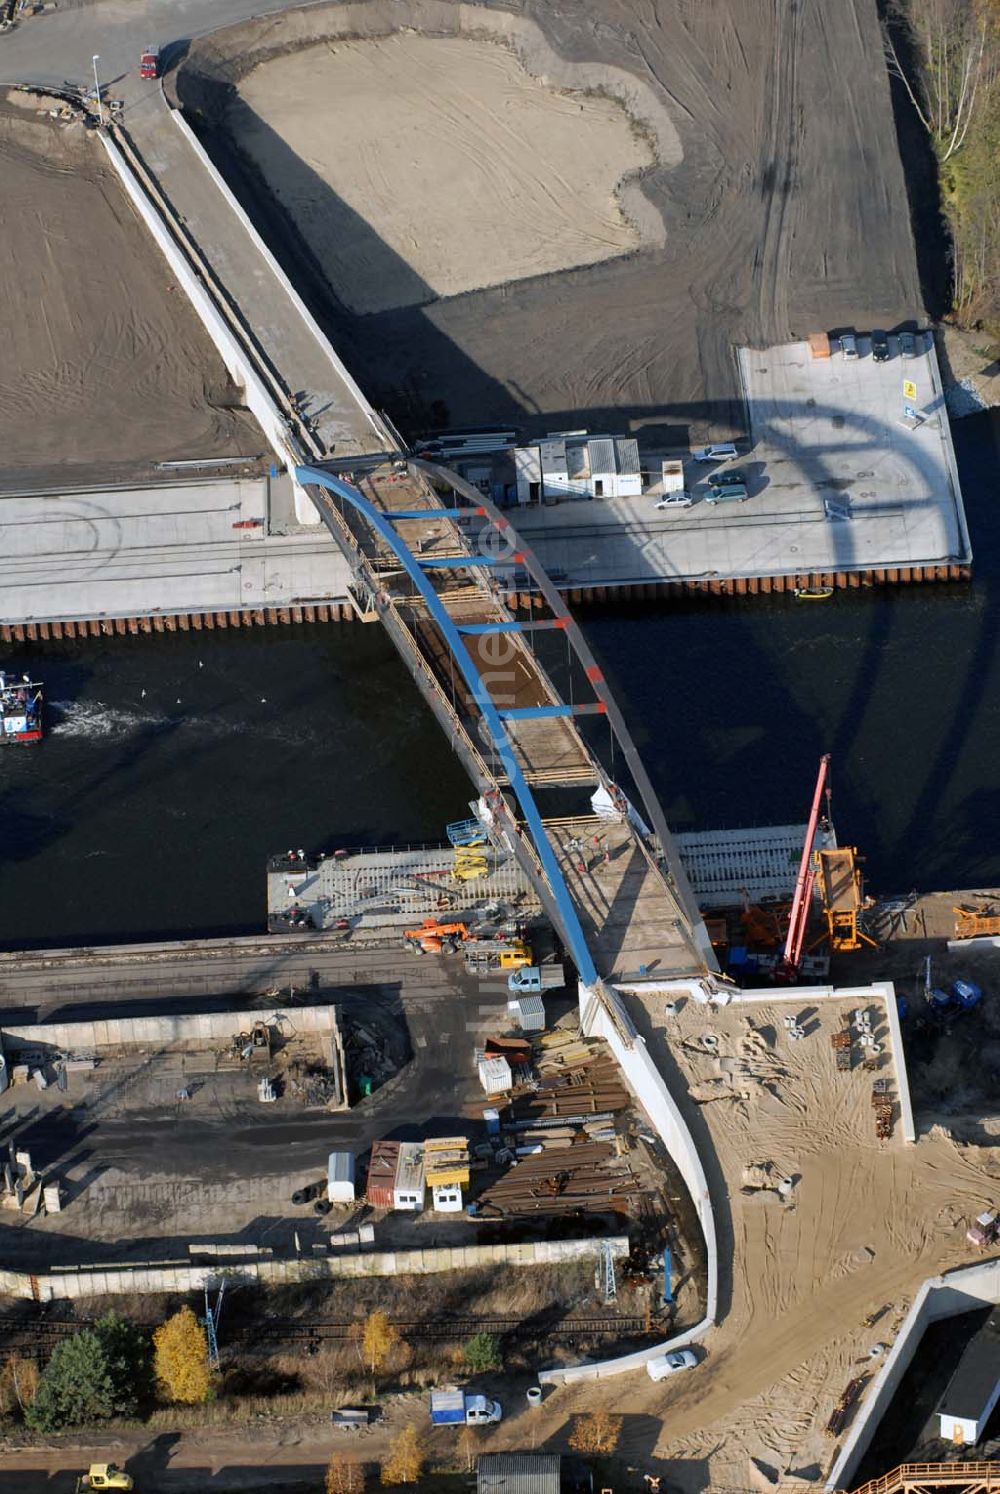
left=523, top=1001, right=1000, bottom=1494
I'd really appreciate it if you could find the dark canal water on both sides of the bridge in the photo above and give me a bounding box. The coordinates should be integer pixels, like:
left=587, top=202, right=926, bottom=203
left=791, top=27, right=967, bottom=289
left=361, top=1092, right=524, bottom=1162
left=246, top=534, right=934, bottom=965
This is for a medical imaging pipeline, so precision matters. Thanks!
left=0, top=412, right=1000, bottom=949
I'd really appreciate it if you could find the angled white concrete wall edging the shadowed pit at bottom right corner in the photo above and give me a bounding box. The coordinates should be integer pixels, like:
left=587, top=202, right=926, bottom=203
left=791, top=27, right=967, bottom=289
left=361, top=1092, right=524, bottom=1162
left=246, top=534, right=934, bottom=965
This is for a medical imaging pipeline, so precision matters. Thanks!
left=825, top=1259, right=1000, bottom=1491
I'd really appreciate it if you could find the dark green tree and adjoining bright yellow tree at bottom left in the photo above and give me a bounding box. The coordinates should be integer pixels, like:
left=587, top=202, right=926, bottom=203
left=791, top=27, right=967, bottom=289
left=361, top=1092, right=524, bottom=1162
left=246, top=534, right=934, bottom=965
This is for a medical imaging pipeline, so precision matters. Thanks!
left=0, top=1307, right=212, bottom=1431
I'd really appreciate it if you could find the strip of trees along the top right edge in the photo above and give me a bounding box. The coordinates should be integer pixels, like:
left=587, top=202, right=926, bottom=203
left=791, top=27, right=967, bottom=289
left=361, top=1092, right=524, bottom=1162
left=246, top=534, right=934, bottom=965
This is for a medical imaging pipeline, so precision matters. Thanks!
left=883, top=0, right=1000, bottom=333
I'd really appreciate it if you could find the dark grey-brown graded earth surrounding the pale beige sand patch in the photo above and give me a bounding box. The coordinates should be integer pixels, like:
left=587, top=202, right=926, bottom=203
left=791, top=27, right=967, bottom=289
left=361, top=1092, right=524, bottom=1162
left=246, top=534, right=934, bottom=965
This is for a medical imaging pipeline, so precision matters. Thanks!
left=176, top=0, right=921, bottom=435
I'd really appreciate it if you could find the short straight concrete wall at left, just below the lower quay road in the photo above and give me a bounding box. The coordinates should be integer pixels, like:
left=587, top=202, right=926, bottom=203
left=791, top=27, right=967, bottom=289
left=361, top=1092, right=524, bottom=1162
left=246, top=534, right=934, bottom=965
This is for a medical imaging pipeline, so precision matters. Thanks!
left=1, top=1005, right=336, bottom=1059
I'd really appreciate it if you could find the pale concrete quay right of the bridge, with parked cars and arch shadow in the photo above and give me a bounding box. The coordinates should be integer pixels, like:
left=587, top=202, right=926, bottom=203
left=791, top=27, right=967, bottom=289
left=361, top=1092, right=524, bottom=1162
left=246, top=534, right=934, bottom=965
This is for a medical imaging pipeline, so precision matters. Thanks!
left=499, top=333, right=972, bottom=601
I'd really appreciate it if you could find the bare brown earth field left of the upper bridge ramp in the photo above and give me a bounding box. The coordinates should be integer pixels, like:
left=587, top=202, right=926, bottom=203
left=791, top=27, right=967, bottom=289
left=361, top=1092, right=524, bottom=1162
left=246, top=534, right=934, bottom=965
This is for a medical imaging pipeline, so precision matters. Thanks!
left=0, top=93, right=263, bottom=487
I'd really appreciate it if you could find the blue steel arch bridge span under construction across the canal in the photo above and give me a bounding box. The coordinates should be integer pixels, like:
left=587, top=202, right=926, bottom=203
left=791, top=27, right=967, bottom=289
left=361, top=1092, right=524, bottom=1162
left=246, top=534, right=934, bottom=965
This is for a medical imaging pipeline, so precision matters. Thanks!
left=294, top=457, right=717, bottom=1013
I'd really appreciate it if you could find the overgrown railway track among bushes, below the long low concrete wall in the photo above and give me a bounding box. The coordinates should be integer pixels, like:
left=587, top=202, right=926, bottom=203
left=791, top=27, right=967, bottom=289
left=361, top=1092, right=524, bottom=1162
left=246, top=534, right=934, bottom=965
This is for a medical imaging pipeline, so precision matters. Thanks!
left=0, top=1313, right=653, bottom=1358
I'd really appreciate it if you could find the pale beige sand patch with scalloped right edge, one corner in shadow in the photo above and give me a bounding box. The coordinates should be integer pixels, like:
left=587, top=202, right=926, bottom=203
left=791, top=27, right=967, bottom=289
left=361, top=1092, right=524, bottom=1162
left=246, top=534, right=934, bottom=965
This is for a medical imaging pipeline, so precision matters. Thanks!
left=229, top=33, right=653, bottom=312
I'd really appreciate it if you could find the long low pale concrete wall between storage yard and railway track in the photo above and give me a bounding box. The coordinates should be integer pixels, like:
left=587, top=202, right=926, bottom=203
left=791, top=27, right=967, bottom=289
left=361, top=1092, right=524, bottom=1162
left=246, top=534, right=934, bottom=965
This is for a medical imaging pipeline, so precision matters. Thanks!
left=0, top=1236, right=628, bottom=1303
